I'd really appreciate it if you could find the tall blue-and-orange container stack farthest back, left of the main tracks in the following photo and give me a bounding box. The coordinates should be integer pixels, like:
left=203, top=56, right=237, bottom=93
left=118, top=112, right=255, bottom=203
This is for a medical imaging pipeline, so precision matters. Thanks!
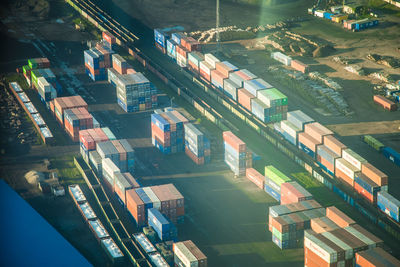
left=83, top=43, right=114, bottom=81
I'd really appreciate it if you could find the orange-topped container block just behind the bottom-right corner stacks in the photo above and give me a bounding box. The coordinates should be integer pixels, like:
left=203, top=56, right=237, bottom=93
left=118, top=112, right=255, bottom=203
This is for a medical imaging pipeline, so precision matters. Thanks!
left=268, top=200, right=325, bottom=249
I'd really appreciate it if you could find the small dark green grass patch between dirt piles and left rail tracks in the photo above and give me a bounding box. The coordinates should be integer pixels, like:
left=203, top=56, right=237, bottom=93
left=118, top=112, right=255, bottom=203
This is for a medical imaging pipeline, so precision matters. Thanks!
left=50, top=155, right=85, bottom=185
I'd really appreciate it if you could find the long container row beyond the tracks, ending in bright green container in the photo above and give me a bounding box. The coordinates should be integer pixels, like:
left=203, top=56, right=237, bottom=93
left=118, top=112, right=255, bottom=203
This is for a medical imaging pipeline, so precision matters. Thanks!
left=155, top=29, right=290, bottom=123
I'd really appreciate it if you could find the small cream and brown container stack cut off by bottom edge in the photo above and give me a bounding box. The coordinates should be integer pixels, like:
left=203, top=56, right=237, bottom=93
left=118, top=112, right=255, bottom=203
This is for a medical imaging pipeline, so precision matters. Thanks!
left=172, top=240, right=207, bottom=267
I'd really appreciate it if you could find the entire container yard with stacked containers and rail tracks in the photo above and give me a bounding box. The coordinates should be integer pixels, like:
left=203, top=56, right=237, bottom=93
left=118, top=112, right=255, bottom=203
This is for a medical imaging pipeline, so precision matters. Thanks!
left=0, top=0, right=400, bottom=266
